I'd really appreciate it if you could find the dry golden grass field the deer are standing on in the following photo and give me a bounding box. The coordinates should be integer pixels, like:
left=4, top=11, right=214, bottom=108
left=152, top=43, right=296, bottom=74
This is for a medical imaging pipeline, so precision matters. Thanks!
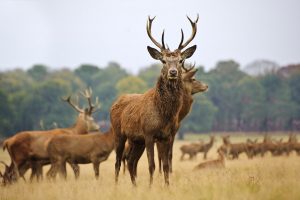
left=0, top=135, right=300, bottom=200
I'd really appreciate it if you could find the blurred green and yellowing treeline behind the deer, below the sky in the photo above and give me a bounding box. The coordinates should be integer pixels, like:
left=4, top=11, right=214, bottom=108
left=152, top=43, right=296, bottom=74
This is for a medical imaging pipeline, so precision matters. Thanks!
left=0, top=60, right=300, bottom=137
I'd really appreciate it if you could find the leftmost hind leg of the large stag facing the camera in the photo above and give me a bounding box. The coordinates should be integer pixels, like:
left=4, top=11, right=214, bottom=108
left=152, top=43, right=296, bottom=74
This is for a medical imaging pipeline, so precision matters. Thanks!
left=115, top=134, right=127, bottom=183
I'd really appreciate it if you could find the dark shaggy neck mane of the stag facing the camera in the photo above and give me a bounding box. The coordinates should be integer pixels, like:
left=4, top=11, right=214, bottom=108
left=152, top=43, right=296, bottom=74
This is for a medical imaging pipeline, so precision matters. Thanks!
left=154, top=76, right=183, bottom=122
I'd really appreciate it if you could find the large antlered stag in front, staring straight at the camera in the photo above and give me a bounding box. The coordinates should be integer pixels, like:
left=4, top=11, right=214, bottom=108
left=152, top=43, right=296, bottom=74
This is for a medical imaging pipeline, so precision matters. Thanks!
left=110, top=17, right=197, bottom=185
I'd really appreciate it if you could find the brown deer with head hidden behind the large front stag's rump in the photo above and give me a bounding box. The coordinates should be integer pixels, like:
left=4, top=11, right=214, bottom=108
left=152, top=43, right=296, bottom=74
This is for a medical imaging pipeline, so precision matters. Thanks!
left=47, top=130, right=114, bottom=179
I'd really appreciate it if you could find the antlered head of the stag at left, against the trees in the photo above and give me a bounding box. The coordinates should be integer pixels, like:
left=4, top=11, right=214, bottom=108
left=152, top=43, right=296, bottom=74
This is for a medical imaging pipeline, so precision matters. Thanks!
left=63, top=88, right=100, bottom=132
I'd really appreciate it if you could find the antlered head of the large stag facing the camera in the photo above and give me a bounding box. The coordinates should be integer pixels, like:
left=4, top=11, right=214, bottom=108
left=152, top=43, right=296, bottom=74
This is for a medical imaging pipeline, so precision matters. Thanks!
left=147, top=16, right=199, bottom=81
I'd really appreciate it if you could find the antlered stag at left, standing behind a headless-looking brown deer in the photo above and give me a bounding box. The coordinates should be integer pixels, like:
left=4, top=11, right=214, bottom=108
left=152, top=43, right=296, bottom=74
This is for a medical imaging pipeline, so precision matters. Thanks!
left=3, top=89, right=99, bottom=184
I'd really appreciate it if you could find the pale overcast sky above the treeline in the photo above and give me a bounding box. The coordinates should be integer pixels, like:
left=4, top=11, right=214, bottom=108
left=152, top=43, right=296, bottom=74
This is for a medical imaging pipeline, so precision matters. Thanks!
left=0, top=0, right=300, bottom=72
